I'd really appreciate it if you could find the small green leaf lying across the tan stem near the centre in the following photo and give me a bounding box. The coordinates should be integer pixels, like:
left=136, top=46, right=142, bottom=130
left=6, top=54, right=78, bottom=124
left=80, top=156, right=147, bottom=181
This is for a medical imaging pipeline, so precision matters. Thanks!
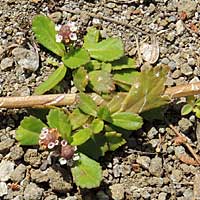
left=79, top=93, right=97, bottom=117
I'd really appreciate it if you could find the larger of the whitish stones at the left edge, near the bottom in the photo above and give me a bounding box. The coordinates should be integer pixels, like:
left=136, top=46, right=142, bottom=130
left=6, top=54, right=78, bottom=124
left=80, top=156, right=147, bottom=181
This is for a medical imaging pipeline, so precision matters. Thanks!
left=0, top=160, right=15, bottom=181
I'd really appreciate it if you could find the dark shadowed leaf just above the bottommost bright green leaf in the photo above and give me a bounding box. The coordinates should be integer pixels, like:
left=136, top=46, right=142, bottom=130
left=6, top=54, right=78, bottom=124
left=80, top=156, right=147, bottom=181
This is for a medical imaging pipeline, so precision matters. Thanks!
left=78, top=133, right=108, bottom=160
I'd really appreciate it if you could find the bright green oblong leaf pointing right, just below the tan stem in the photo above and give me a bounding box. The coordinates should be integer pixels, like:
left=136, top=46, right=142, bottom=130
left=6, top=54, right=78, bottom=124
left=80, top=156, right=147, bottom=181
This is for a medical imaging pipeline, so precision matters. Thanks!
left=112, top=112, right=143, bottom=130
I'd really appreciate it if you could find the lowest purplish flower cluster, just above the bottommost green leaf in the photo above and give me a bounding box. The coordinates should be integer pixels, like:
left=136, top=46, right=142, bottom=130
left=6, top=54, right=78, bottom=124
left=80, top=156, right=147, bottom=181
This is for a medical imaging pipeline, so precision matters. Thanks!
left=59, top=140, right=80, bottom=166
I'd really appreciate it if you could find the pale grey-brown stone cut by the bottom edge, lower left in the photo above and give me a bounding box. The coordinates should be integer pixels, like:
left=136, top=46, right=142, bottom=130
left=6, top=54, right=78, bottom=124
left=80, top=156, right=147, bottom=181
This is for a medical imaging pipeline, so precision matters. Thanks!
left=24, top=183, right=44, bottom=200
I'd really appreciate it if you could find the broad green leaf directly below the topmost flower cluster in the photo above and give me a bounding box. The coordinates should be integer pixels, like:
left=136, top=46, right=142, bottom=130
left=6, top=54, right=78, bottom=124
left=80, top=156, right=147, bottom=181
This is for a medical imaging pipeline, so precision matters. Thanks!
left=62, top=48, right=90, bottom=69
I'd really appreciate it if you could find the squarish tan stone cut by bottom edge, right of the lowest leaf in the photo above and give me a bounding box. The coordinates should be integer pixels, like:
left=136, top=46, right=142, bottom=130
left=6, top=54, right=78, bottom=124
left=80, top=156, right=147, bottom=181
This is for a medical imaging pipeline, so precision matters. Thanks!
left=109, top=184, right=125, bottom=200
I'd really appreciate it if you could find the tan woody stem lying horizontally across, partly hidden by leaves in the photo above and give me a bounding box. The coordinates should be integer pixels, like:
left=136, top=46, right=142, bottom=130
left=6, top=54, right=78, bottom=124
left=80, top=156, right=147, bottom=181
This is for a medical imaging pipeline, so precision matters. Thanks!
left=0, top=82, right=200, bottom=108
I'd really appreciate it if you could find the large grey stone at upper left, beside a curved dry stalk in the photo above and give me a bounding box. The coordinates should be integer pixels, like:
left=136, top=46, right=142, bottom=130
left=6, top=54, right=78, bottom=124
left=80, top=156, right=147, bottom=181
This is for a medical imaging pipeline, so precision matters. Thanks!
left=12, top=48, right=39, bottom=72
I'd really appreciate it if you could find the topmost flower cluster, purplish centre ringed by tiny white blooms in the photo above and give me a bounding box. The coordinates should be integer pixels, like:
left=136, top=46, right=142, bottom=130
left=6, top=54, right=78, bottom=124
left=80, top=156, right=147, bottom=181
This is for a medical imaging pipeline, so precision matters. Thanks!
left=55, top=22, right=78, bottom=43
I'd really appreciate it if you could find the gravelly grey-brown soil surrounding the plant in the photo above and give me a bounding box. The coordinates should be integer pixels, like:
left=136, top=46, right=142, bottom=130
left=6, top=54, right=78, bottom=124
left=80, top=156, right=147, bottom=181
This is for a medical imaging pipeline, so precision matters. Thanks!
left=0, top=0, right=200, bottom=200
